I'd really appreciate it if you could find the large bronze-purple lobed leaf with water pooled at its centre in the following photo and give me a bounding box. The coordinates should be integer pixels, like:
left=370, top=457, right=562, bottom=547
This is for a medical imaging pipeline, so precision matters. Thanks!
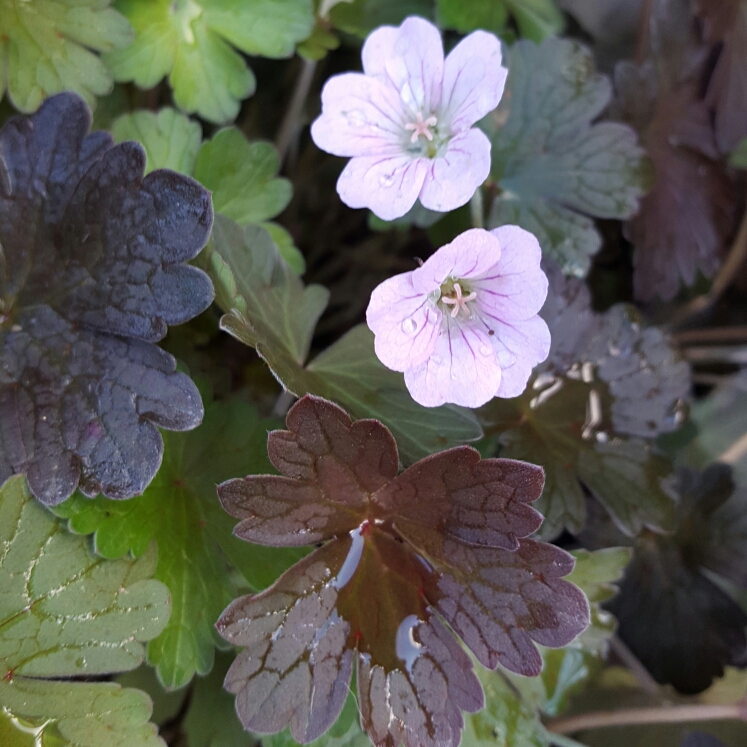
left=218, top=396, right=589, bottom=747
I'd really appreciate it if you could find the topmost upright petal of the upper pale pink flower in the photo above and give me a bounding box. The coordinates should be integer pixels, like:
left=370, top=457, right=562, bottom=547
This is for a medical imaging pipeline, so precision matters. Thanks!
left=361, top=16, right=444, bottom=114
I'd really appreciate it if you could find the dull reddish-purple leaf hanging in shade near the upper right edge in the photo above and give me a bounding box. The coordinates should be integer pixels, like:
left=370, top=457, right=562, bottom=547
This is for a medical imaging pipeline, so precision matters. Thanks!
left=614, top=6, right=735, bottom=301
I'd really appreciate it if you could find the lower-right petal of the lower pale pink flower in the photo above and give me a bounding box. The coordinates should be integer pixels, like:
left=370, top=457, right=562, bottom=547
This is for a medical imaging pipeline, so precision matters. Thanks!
left=480, top=313, right=550, bottom=397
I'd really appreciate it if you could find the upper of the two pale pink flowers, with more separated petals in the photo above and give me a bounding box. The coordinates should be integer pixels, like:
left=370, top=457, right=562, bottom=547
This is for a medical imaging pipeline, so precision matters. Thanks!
left=311, top=17, right=508, bottom=220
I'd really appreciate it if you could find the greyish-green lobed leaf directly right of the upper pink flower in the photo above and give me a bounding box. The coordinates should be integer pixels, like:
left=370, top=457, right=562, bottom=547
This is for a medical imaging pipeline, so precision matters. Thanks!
left=482, top=38, right=651, bottom=276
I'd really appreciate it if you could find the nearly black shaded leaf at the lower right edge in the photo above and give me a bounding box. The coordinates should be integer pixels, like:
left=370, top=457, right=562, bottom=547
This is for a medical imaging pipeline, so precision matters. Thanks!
left=600, top=464, right=747, bottom=693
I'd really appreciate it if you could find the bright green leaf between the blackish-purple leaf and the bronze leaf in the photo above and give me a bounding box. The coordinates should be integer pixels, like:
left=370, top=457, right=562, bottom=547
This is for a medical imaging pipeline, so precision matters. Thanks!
left=57, top=399, right=305, bottom=688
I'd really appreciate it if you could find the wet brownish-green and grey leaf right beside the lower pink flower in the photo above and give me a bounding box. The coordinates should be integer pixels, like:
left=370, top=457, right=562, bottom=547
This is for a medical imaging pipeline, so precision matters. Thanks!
left=480, top=263, right=690, bottom=536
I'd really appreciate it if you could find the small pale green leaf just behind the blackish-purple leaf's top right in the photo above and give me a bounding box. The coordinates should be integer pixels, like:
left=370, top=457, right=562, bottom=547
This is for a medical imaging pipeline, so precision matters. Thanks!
left=112, top=109, right=203, bottom=175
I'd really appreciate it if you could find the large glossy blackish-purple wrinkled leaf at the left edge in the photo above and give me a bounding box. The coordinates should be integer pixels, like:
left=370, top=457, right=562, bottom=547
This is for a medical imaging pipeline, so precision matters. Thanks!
left=0, top=94, right=213, bottom=505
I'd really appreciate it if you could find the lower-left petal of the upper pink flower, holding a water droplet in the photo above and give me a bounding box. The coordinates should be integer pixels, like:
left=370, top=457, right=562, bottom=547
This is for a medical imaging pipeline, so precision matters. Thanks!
left=337, top=156, right=428, bottom=220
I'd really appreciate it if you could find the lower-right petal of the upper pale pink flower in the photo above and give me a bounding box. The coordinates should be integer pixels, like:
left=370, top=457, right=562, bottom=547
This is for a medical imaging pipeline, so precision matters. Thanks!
left=420, top=129, right=490, bottom=212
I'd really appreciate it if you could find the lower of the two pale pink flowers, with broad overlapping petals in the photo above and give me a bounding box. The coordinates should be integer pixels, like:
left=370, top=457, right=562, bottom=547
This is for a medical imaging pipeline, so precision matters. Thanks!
left=366, top=226, right=550, bottom=407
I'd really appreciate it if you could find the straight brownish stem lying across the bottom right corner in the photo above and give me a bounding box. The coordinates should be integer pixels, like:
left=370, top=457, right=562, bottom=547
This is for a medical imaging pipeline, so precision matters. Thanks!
left=547, top=701, right=747, bottom=737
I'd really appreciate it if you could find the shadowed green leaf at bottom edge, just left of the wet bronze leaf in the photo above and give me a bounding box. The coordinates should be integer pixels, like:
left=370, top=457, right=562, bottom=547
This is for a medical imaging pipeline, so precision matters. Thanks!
left=183, top=653, right=254, bottom=747
